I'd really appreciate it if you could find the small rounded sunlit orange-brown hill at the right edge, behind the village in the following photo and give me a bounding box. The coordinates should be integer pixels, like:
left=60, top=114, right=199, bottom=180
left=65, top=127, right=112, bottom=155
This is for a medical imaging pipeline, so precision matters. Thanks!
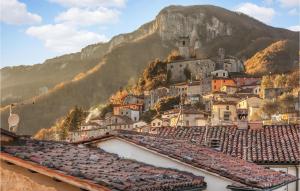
left=245, top=40, right=299, bottom=75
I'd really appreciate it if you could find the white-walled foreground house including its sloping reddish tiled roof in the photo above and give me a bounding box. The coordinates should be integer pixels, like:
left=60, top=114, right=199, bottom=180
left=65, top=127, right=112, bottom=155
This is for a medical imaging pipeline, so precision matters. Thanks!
left=83, top=131, right=296, bottom=191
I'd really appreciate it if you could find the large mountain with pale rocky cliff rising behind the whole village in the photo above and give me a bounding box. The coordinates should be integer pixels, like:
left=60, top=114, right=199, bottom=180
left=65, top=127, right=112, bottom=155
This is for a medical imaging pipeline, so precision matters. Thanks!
left=1, top=5, right=298, bottom=134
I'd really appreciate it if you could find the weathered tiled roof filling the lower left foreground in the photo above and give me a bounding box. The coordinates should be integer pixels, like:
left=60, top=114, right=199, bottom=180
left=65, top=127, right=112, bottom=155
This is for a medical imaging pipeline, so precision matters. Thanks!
left=1, top=139, right=205, bottom=191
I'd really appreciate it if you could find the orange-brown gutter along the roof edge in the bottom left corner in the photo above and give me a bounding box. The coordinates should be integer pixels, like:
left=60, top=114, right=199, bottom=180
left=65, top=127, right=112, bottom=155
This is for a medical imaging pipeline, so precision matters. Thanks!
left=0, top=152, right=111, bottom=191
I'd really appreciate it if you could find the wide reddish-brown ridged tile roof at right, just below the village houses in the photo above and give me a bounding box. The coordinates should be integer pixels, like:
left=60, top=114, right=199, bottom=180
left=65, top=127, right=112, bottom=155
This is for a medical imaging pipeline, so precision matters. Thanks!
left=158, top=125, right=300, bottom=164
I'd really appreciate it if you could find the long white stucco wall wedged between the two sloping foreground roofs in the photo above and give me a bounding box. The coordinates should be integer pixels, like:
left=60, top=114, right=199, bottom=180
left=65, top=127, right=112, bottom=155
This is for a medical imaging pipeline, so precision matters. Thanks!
left=96, top=138, right=236, bottom=191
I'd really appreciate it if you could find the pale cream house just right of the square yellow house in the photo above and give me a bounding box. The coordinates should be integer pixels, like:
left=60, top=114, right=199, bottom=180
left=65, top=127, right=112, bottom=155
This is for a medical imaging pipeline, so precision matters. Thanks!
left=237, top=96, right=263, bottom=119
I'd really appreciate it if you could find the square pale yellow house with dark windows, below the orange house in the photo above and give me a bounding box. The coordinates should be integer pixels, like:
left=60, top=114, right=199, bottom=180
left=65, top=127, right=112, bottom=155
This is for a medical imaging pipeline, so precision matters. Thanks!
left=211, top=101, right=237, bottom=125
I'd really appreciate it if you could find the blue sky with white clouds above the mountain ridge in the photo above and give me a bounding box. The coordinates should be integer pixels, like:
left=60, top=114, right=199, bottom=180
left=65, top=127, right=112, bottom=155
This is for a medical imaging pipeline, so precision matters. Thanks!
left=0, top=0, right=300, bottom=68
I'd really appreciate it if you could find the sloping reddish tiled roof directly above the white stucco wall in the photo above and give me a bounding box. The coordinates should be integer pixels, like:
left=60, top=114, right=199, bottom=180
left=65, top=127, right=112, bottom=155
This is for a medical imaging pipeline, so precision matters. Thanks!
left=116, top=133, right=296, bottom=190
